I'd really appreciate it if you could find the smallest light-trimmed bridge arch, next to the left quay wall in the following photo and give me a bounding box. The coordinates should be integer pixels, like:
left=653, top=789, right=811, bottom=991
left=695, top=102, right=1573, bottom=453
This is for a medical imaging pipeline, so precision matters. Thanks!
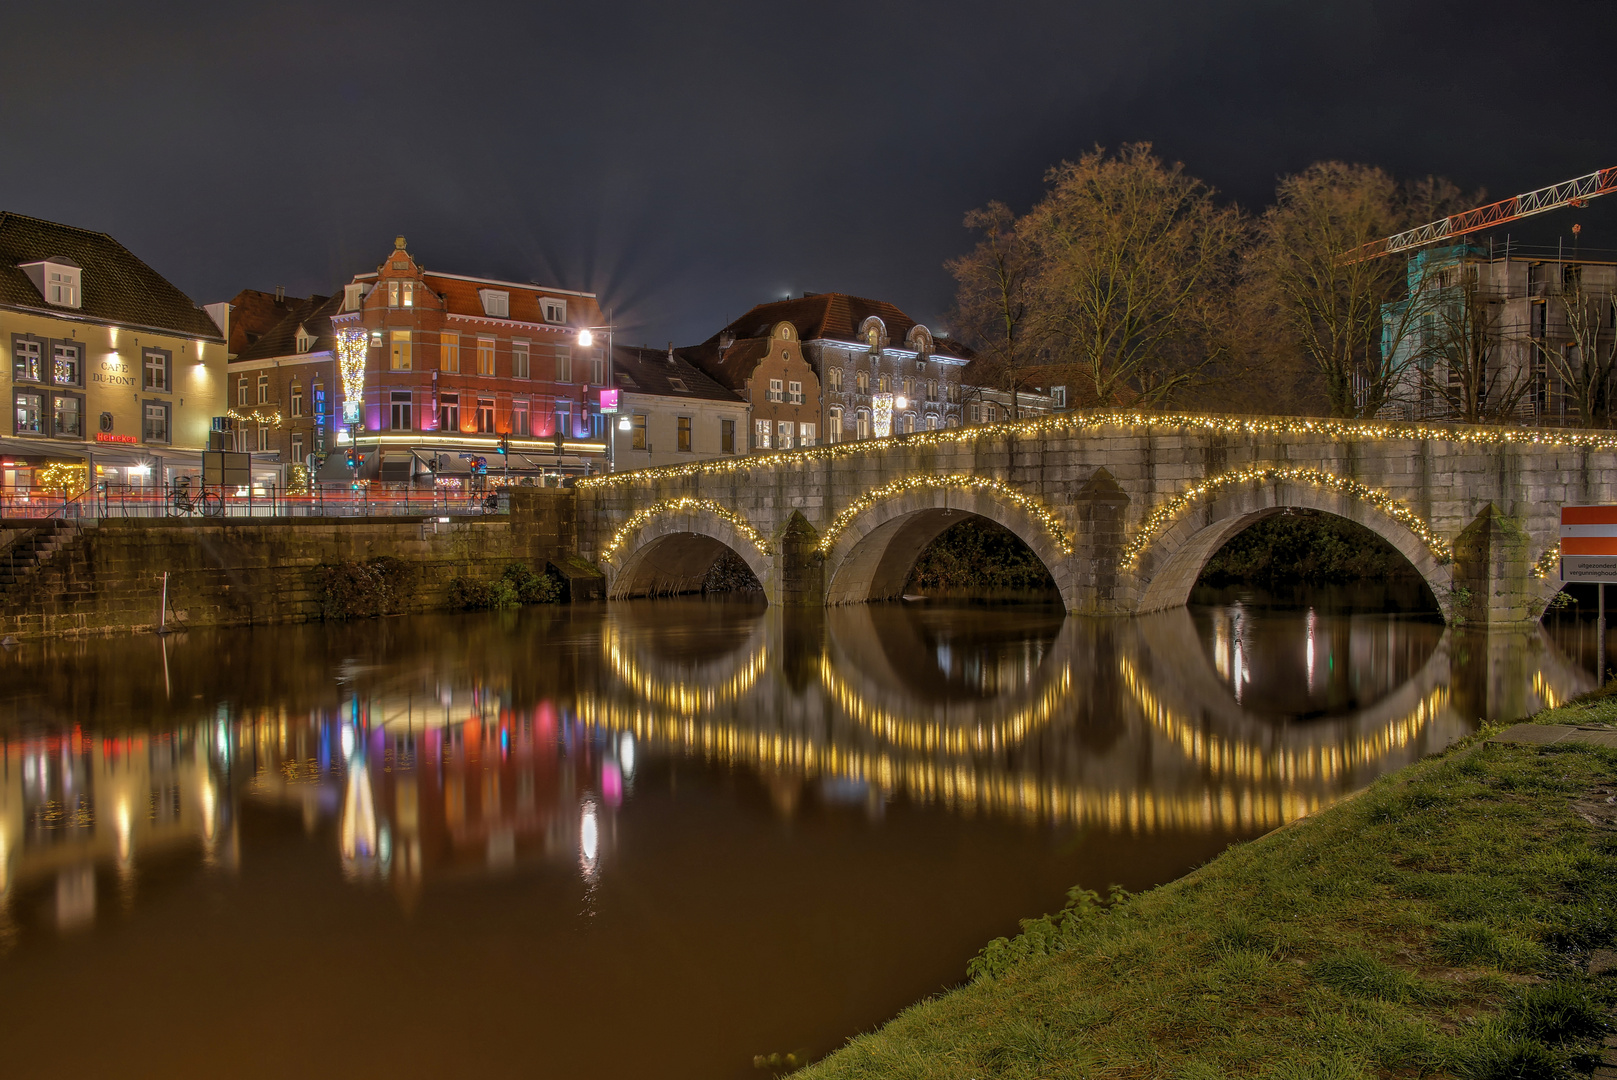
left=600, top=500, right=776, bottom=603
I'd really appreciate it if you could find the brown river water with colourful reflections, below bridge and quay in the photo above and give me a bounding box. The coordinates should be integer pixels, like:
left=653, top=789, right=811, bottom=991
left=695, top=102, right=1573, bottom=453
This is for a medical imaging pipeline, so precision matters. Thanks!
left=0, top=590, right=1593, bottom=1080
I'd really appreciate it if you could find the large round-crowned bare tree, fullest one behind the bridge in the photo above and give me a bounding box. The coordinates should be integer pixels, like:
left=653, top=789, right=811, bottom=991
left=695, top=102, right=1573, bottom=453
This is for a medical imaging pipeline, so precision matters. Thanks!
left=1019, top=142, right=1247, bottom=406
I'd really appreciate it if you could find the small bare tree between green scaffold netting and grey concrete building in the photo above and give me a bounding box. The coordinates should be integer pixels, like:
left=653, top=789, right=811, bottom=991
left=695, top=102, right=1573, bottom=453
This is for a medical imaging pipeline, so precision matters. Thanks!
left=1415, top=276, right=1533, bottom=424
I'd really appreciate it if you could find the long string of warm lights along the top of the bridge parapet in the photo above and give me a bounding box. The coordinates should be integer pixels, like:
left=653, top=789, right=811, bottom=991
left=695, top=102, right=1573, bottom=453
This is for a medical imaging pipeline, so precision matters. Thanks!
left=577, top=409, right=1617, bottom=488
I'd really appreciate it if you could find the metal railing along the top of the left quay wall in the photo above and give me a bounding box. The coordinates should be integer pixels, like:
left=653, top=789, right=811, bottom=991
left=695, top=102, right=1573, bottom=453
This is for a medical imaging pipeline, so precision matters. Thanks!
left=0, top=482, right=509, bottom=521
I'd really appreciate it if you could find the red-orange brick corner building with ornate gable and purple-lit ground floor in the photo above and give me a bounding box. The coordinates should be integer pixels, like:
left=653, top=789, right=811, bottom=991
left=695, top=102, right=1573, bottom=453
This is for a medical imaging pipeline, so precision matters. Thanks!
left=327, top=236, right=606, bottom=482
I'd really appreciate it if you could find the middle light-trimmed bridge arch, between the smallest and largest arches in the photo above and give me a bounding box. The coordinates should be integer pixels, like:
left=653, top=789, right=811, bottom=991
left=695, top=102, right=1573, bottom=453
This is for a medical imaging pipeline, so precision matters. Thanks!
left=820, top=475, right=1077, bottom=611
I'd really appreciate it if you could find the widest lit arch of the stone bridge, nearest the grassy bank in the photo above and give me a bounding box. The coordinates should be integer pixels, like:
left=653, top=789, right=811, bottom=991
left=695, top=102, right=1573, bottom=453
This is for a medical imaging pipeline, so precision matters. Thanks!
left=1125, top=466, right=1450, bottom=614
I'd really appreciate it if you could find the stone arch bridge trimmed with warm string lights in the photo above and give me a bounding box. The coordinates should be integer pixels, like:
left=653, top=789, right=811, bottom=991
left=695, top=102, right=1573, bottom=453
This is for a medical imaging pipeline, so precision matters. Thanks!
left=577, top=412, right=1617, bottom=626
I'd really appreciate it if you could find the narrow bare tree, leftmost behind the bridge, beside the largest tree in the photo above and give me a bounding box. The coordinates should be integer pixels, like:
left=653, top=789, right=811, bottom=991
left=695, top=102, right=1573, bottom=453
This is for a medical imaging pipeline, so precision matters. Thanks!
left=944, top=202, right=1033, bottom=419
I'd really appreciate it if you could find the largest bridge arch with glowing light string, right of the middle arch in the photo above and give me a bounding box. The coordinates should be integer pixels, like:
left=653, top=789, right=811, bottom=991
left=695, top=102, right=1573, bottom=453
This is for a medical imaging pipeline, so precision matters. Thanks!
left=1134, top=477, right=1454, bottom=618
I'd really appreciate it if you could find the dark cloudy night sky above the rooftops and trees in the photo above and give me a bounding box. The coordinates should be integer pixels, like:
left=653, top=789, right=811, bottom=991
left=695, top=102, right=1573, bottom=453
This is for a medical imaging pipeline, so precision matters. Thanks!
left=9, top=0, right=1617, bottom=344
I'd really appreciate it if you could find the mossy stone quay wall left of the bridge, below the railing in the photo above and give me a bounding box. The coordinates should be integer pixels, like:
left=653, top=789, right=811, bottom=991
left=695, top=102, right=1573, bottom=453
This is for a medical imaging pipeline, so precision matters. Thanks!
left=0, top=490, right=576, bottom=639
